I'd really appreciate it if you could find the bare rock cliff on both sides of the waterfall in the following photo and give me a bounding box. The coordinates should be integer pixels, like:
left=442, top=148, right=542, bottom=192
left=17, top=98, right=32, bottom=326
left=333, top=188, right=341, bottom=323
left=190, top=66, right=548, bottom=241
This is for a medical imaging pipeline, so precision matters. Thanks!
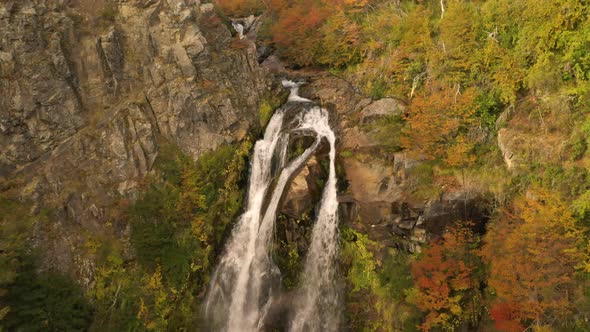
left=0, top=0, right=486, bottom=298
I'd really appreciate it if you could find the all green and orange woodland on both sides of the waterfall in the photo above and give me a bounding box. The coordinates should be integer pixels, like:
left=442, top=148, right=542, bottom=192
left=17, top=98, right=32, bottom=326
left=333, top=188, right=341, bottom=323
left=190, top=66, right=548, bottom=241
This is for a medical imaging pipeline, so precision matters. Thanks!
left=0, top=0, right=590, bottom=332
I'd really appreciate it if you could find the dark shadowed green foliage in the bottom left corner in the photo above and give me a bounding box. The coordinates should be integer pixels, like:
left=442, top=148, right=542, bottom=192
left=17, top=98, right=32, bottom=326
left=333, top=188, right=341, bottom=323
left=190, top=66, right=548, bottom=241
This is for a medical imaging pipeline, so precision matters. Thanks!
left=0, top=193, right=76, bottom=331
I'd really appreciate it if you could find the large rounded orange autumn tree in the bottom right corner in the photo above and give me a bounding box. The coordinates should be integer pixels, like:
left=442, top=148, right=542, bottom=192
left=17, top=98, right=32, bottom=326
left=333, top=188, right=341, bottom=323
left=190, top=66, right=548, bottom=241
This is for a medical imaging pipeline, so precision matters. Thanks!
left=482, top=189, right=583, bottom=331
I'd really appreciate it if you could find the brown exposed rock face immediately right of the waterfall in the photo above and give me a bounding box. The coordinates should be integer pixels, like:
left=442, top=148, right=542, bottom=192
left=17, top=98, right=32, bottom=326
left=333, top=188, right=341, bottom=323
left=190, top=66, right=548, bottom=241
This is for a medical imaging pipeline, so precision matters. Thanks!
left=284, top=76, right=488, bottom=251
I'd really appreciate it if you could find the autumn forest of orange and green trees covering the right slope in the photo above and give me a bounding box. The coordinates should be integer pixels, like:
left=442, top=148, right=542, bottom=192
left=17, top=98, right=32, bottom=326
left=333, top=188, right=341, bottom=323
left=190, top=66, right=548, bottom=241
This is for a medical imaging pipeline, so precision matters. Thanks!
left=224, top=0, right=590, bottom=331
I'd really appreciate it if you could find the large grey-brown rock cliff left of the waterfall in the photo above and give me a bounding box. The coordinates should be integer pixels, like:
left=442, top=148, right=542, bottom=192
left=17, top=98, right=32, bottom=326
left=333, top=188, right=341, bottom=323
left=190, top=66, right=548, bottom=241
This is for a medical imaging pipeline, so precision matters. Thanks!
left=0, top=0, right=267, bottom=282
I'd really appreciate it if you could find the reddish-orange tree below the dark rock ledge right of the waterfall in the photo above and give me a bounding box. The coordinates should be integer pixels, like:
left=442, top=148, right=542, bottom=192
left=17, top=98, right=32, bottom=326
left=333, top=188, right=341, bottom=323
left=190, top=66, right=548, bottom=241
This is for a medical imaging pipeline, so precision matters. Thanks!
left=409, top=223, right=481, bottom=331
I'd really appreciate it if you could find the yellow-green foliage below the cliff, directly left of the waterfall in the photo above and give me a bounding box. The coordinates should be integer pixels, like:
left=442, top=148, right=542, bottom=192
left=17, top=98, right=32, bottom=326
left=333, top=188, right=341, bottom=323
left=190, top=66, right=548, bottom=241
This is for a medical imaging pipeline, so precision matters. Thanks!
left=90, top=140, right=252, bottom=331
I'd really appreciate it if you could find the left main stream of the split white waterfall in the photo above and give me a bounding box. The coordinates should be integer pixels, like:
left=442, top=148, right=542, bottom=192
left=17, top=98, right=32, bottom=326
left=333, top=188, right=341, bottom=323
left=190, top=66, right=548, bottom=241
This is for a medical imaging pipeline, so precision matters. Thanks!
left=205, top=110, right=287, bottom=331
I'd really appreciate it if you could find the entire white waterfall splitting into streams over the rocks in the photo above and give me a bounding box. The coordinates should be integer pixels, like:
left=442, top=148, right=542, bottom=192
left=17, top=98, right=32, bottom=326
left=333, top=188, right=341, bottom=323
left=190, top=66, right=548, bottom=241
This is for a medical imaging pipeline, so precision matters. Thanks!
left=205, top=81, right=339, bottom=332
